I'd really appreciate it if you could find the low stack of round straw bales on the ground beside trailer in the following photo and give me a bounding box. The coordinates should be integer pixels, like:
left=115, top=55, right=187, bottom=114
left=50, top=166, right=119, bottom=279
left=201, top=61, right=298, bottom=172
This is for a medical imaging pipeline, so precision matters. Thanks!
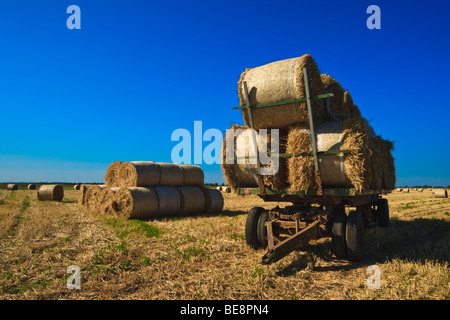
left=79, top=161, right=223, bottom=219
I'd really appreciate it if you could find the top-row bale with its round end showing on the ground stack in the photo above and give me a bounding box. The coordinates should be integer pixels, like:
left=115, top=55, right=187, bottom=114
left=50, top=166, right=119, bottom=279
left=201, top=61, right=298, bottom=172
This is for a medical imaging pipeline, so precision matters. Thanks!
left=117, top=161, right=161, bottom=187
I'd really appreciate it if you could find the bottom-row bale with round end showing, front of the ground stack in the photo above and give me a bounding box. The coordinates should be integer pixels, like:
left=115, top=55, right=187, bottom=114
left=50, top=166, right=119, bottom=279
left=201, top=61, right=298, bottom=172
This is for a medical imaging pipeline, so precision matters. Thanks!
left=113, top=187, right=158, bottom=219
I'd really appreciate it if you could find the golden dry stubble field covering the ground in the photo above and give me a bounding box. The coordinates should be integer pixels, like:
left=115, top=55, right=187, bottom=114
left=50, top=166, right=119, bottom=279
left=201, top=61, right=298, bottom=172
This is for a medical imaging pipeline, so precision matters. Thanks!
left=0, top=190, right=450, bottom=300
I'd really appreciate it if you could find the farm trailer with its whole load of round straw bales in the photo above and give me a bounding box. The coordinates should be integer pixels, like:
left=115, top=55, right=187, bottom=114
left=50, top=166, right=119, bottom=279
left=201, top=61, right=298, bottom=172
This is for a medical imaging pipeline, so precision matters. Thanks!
left=222, top=55, right=395, bottom=264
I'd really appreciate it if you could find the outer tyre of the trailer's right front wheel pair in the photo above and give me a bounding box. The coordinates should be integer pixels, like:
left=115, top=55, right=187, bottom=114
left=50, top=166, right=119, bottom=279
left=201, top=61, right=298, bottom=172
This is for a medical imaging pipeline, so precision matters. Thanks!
left=345, top=211, right=364, bottom=261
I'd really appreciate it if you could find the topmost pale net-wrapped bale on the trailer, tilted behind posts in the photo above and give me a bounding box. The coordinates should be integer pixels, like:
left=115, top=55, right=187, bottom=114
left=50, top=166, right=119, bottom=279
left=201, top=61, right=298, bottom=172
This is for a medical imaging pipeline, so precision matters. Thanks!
left=238, top=54, right=324, bottom=129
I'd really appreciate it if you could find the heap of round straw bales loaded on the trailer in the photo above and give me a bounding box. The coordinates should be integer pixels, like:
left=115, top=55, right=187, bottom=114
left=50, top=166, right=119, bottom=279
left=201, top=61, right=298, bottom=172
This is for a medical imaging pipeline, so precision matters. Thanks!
left=221, top=55, right=395, bottom=191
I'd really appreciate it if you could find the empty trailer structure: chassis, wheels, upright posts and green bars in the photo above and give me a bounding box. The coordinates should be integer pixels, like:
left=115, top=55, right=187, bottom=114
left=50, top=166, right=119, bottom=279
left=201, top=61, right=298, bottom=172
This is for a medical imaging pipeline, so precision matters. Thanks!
left=233, top=68, right=390, bottom=264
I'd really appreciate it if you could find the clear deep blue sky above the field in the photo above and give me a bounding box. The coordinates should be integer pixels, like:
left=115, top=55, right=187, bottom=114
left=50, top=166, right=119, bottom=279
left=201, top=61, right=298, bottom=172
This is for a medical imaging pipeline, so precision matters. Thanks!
left=0, top=0, right=450, bottom=185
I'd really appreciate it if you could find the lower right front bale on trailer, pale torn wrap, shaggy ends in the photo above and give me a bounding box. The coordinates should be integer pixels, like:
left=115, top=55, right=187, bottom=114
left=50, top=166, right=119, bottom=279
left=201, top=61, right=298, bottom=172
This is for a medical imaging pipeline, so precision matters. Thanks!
left=286, top=118, right=380, bottom=191
